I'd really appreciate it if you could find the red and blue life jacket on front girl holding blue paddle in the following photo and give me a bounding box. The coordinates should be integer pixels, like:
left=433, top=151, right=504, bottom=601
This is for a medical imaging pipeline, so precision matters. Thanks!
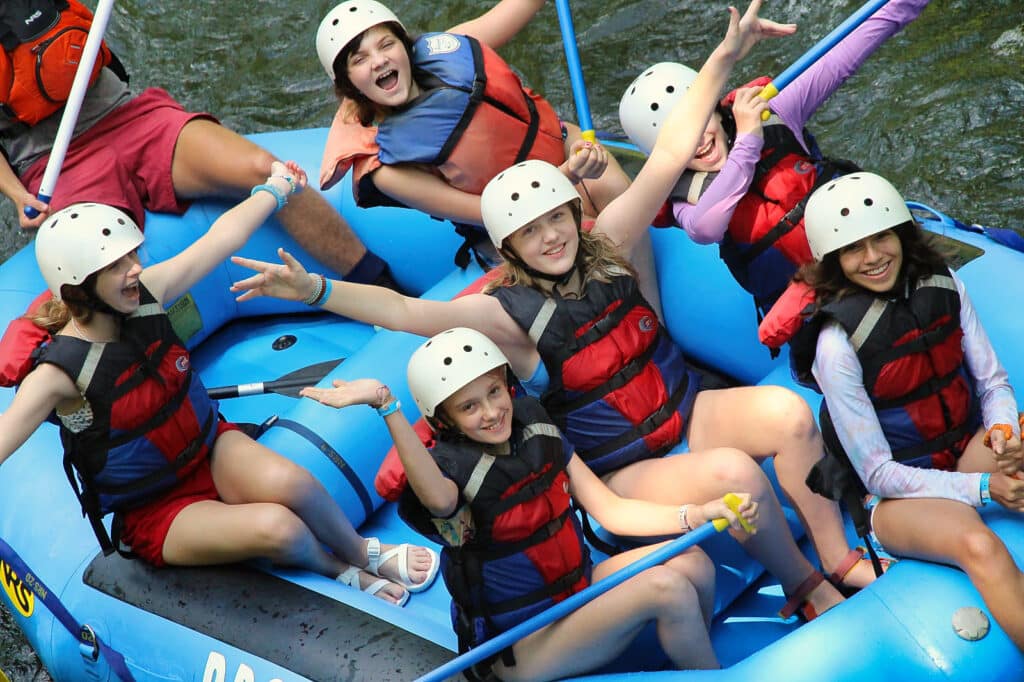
left=399, top=396, right=591, bottom=667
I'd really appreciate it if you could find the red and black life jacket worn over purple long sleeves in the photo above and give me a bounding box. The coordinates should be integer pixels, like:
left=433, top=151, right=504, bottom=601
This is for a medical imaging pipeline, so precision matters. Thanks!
left=671, top=104, right=857, bottom=315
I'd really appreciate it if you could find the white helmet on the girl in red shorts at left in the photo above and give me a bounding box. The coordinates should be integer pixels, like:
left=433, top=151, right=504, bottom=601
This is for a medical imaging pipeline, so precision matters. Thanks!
left=36, top=204, right=144, bottom=301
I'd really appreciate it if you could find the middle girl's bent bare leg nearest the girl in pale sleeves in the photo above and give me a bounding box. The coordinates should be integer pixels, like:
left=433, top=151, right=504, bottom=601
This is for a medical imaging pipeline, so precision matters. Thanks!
left=688, top=386, right=874, bottom=587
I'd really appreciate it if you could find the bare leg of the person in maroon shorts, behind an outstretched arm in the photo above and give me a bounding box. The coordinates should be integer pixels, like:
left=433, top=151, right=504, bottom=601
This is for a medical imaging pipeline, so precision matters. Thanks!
left=172, top=119, right=367, bottom=275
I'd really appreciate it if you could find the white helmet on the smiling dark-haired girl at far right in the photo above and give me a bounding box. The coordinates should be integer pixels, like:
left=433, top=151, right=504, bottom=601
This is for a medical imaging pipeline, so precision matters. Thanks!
left=804, top=172, right=913, bottom=260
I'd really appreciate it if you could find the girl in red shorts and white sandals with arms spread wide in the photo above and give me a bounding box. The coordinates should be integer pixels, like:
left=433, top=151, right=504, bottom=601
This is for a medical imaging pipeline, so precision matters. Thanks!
left=0, top=162, right=437, bottom=604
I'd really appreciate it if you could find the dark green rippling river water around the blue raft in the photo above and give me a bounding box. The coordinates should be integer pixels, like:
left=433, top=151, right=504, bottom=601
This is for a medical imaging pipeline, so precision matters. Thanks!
left=0, top=0, right=1024, bottom=682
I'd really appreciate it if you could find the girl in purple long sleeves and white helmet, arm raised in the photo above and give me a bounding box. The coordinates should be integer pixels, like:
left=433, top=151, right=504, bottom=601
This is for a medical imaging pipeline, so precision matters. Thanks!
left=618, top=0, right=929, bottom=318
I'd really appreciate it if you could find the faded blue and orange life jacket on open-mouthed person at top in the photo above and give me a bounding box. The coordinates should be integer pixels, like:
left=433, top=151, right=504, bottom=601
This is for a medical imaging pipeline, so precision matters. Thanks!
left=321, top=33, right=565, bottom=201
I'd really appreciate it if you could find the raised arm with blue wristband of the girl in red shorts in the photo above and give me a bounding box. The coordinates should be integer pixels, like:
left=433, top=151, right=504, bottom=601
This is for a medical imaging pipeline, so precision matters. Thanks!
left=141, top=161, right=306, bottom=301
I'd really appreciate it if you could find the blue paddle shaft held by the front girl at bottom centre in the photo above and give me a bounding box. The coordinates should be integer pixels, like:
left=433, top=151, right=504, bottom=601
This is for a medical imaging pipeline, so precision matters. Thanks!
left=417, top=522, right=718, bottom=682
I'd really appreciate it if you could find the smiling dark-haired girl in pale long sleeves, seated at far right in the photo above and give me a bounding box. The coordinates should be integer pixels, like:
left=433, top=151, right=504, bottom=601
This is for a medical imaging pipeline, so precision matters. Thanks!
left=765, top=173, right=1024, bottom=649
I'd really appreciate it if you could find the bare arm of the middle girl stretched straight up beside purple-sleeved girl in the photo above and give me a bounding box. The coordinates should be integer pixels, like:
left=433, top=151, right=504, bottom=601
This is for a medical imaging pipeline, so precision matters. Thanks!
left=595, top=0, right=796, bottom=251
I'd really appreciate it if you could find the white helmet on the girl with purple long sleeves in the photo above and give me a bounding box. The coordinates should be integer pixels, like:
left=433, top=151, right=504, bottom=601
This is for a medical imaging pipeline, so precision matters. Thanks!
left=618, top=61, right=697, bottom=154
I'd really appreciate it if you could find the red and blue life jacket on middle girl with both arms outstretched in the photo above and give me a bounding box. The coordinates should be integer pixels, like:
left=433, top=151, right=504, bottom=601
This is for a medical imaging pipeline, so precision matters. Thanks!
left=492, top=271, right=700, bottom=475
